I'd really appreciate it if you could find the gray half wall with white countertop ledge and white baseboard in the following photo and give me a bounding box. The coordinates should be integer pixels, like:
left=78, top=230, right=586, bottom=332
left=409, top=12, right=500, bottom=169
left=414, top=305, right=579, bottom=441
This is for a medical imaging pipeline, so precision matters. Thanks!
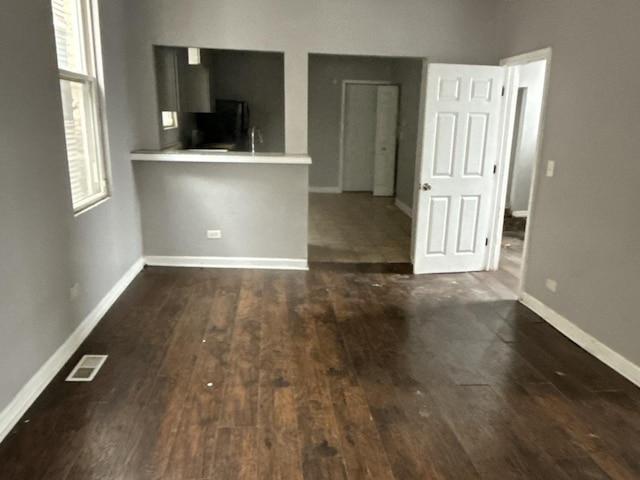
left=131, top=150, right=311, bottom=270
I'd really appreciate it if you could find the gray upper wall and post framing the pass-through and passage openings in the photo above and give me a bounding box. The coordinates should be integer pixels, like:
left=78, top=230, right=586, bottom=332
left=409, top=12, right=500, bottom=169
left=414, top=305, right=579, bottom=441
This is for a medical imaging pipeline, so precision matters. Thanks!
left=127, top=0, right=498, bottom=153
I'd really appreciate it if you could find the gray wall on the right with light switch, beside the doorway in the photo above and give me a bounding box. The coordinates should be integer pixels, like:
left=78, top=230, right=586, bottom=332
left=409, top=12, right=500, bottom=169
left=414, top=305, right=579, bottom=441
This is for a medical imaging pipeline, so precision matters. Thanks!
left=502, top=0, right=640, bottom=365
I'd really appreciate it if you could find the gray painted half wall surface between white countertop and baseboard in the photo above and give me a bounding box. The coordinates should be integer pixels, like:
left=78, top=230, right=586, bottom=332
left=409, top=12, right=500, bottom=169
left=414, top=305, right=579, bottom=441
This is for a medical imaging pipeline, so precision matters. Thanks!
left=135, top=162, right=309, bottom=259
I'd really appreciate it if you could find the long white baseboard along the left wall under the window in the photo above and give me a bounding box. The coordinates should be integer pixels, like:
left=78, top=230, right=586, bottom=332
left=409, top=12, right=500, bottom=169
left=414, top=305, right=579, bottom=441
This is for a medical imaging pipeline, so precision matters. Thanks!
left=0, top=259, right=144, bottom=442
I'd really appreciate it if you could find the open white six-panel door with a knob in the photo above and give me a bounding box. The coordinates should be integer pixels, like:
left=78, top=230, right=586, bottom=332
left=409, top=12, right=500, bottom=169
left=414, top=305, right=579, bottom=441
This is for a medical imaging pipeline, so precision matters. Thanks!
left=413, top=64, right=505, bottom=273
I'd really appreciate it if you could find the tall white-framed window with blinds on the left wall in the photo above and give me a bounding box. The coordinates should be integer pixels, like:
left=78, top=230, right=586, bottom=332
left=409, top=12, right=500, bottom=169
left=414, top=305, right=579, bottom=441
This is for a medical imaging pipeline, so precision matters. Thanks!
left=51, top=0, right=108, bottom=212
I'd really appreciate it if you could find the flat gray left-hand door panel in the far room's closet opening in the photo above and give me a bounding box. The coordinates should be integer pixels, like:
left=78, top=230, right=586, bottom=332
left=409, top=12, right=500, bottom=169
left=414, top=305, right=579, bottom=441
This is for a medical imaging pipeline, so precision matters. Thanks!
left=342, top=83, right=378, bottom=192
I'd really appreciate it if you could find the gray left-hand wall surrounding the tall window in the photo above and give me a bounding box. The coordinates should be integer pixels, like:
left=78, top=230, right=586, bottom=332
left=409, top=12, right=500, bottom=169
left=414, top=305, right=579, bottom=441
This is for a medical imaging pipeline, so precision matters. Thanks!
left=0, top=0, right=141, bottom=411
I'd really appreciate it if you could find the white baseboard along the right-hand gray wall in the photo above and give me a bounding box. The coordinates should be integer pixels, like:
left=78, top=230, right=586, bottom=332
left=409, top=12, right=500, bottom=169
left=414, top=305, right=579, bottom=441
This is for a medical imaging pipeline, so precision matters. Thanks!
left=521, top=293, right=640, bottom=386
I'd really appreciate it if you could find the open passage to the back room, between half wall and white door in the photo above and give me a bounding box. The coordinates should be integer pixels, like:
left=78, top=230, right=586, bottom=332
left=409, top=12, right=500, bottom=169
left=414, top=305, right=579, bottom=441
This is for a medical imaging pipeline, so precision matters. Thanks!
left=308, top=54, right=424, bottom=264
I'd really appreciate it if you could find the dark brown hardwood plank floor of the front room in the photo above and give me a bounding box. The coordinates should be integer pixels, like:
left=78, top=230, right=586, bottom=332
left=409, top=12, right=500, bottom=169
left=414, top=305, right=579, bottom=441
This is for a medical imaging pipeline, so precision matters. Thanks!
left=0, top=253, right=640, bottom=480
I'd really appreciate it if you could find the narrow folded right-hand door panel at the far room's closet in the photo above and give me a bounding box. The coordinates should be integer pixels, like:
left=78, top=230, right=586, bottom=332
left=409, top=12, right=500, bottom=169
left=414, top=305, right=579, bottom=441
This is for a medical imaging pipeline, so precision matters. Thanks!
left=373, top=85, right=399, bottom=197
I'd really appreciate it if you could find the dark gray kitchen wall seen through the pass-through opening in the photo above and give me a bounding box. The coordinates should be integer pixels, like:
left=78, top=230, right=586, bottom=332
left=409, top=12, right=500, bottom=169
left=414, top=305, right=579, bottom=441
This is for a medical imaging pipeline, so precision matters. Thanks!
left=208, top=50, right=284, bottom=152
